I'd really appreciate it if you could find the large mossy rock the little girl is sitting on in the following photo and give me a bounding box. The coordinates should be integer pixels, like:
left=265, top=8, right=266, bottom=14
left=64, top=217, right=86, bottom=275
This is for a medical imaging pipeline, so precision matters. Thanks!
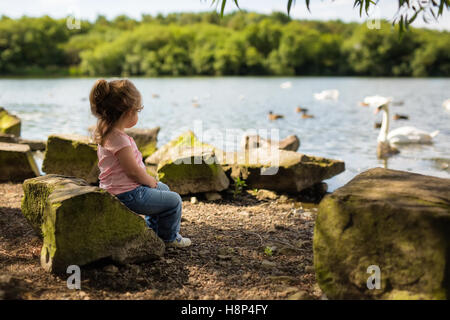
left=22, top=174, right=165, bottom=273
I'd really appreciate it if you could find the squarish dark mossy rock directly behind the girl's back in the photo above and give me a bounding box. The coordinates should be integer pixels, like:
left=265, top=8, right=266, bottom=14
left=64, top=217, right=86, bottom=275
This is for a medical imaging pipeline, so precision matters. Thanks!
left=42, top=134, right=100, bottom=183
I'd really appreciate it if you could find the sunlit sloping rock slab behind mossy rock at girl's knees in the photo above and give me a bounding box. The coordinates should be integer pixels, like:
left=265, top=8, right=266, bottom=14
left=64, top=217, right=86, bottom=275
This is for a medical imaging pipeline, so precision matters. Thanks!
left=145, top=130, right=216, bottom=166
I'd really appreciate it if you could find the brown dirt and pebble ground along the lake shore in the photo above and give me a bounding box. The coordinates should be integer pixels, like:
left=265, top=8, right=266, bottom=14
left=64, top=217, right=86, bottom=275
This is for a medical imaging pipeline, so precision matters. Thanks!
left=0, top=183, right=322, bottom=299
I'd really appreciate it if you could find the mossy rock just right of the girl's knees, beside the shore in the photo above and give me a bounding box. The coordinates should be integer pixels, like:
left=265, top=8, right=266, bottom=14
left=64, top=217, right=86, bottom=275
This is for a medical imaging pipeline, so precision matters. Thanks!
left=157, top=148, right=230, bottom=195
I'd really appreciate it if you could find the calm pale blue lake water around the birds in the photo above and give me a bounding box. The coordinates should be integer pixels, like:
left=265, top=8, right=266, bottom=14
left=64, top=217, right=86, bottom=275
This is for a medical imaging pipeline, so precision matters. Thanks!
left=0, top=77, right=450, bottom=190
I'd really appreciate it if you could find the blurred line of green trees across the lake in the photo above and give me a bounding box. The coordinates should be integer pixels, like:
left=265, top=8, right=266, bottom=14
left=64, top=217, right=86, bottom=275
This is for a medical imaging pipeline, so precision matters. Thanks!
left=0, top=11, right=450, bottom=77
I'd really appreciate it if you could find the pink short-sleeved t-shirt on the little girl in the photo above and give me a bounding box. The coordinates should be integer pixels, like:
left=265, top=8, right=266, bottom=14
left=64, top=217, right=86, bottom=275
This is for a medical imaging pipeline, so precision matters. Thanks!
left=97, top=128, right=145, bottom=195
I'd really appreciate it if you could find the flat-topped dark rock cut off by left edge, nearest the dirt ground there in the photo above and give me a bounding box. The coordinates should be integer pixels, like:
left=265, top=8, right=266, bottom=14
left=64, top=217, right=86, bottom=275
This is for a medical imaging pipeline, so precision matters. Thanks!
left=0, top=142, right=40, bottom=182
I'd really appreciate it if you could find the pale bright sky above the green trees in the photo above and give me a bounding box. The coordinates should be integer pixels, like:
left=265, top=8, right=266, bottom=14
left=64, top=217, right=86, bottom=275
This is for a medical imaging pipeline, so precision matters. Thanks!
left=0, top=0, right=450, bottom=31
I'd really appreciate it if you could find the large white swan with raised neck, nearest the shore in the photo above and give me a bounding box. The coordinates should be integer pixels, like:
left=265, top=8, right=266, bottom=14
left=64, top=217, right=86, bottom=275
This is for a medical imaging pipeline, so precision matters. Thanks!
left=375, top=98, right=439, bottom=145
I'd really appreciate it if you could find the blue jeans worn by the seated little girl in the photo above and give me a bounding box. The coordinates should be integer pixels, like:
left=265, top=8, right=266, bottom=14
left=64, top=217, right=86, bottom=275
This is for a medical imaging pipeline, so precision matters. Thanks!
left=116, top=181, right=182, bottom=242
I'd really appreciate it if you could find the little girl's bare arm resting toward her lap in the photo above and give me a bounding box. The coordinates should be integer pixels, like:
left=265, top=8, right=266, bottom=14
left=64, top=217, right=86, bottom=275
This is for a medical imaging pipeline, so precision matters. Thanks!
left=116, top=146, right=158, bottom=188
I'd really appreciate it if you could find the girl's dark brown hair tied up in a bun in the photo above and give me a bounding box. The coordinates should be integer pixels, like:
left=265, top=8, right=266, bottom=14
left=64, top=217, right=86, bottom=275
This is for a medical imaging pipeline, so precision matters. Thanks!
left=89, top=79, right=142, bottom=146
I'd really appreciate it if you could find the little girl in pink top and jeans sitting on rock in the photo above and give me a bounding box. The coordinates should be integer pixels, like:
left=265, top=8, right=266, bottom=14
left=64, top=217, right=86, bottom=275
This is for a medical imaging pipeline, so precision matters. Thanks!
left=89, top=79, right=191, bottom=247
